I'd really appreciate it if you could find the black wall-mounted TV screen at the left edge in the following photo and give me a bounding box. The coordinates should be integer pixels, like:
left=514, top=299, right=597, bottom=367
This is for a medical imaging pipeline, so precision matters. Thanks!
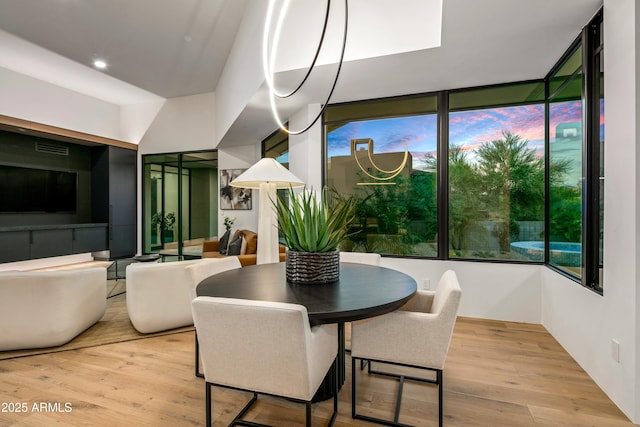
left=0, top=165, right=78, bottom=213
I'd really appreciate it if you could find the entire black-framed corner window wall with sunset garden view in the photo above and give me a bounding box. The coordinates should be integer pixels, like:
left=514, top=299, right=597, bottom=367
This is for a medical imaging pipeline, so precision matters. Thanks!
left=324, top=12, right=604, bottom=292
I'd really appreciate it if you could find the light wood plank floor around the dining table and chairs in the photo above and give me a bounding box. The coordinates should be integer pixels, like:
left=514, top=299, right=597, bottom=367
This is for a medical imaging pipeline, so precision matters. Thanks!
left=0, top=318, right=633, bottom=427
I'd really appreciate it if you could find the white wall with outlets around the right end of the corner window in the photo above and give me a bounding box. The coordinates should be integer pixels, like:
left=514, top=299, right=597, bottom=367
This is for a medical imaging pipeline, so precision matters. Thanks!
left=542, top=0, right=640, bottom=423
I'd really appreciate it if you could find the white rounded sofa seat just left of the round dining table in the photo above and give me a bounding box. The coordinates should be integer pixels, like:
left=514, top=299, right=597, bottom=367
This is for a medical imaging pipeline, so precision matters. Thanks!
left=126, top=259, right=214, bottom=334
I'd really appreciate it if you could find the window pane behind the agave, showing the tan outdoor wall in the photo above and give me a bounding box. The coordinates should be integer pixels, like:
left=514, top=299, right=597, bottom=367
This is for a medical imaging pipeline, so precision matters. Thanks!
left=325, top=95, right=438, bottom=257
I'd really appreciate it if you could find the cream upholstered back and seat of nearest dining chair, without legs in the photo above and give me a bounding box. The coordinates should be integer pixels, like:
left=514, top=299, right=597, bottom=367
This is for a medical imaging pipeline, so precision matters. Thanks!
left=192, top=297, right=338, bottom=400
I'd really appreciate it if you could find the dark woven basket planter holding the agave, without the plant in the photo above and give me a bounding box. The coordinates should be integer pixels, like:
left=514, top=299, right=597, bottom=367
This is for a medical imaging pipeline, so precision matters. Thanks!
left=287, top=250, right=340, bottom=285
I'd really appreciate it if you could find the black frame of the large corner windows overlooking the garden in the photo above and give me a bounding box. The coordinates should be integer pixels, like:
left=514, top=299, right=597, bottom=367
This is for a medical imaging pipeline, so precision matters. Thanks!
left=322, top=9, right=604, bottom=295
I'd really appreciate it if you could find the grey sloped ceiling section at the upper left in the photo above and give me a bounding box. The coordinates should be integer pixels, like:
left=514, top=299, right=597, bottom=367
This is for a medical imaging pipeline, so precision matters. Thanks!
left=0, top=0, right=245, bottom=98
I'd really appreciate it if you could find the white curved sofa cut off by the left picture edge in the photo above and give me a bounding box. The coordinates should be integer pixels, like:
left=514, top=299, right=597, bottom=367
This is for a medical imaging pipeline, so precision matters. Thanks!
left=0, top=267, right=107, bottom=351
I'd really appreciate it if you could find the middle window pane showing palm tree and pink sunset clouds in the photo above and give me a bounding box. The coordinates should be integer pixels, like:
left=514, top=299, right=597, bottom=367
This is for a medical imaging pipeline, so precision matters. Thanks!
left=448, top=82, right=545, bottom=262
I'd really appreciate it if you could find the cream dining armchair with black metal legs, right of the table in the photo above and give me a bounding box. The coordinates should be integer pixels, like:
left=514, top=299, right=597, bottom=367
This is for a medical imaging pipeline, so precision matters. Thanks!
left=351, top=270, right=462, bottom=426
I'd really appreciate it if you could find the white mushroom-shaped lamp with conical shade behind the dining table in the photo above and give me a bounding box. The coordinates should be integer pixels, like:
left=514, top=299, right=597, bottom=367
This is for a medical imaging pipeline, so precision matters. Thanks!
left=230, top=158, right=304, bottom=264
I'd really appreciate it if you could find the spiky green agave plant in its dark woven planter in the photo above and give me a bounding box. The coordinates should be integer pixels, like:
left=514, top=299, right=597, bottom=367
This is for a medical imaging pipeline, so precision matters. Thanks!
left=274, top=187, right=355, bottom=284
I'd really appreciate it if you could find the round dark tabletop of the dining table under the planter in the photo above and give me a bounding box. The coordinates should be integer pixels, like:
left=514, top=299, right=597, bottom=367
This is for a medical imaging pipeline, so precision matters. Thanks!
left=196, top=262, right=416, bottom=325
